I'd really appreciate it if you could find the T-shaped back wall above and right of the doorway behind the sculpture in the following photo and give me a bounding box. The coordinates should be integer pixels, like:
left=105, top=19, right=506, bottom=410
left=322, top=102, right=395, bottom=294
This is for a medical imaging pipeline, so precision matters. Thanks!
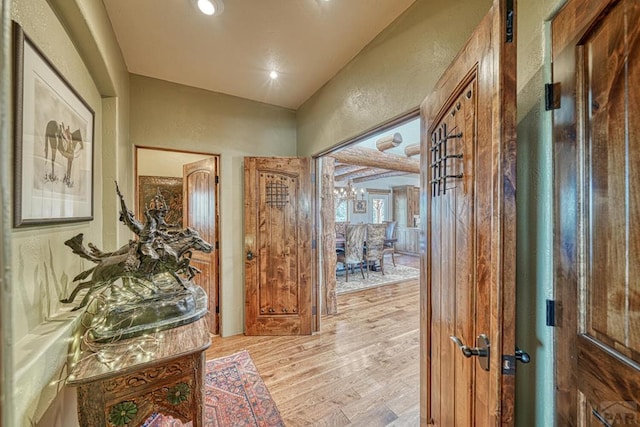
left=131, top=75, right=296, bottom=336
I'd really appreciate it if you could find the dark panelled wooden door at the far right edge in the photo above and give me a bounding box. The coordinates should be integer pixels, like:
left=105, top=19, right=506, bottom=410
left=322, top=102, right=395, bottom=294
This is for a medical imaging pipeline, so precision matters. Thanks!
left=552, top=0, right=640, bottom=426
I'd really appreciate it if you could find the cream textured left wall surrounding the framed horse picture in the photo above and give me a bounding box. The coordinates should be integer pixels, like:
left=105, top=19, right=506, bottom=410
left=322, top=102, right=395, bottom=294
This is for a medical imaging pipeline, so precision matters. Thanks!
left=9, top=0, right=131, bottom=426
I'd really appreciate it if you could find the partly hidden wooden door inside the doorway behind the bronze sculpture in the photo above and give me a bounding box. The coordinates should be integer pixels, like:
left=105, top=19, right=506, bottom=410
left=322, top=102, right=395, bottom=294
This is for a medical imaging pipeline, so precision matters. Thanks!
left=182, top=157, right=220, bottom=334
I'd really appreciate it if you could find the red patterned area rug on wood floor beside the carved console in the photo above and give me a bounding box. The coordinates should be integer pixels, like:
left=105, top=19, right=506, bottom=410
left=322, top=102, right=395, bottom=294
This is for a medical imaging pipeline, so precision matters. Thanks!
left=142, top=350, right=284, bottom=427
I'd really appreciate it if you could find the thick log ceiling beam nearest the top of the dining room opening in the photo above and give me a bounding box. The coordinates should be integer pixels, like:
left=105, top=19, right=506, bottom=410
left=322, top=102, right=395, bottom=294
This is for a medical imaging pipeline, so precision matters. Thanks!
left=329, top=147, right=420, bottom=173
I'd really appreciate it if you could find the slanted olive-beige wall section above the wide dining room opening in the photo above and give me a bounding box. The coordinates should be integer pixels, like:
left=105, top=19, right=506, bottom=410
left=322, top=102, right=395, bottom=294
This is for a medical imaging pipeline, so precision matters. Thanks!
left=298, top=0, right=491, bottom=156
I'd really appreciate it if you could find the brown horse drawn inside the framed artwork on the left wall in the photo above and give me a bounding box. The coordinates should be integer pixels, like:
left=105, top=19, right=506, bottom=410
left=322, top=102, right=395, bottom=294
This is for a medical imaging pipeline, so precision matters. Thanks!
left=44, top=120, right=84, bottom=187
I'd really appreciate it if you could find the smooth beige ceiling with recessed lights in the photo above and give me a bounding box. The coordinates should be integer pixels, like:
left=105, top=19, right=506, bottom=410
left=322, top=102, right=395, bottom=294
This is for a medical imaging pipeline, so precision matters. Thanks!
left=103, top=0, right=415, bottom=109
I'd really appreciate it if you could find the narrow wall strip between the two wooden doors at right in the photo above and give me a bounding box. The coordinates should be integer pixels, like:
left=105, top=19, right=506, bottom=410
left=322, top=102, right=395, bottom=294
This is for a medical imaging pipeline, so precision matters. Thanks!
left=516, top=0, right=564, bottom=426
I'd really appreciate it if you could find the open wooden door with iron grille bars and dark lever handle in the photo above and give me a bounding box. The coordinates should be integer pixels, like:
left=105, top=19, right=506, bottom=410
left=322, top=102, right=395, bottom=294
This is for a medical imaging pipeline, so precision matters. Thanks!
left=421, top=0, right=516, bottom=426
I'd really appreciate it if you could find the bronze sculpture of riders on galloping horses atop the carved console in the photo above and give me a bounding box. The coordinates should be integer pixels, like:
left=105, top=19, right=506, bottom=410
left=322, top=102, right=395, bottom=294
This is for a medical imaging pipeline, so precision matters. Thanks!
left=61, top=184, right=212, bottom=310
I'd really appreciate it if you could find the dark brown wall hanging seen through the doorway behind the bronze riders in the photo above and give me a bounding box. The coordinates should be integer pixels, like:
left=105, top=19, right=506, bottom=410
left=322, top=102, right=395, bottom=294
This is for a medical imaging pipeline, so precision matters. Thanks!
left=136, top=175, right=183, bottom=232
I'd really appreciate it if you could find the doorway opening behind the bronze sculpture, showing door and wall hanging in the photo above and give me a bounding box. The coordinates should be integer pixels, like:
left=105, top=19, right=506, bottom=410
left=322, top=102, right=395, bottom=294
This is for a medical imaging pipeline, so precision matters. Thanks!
left=135, top=146, right=221, bottom=335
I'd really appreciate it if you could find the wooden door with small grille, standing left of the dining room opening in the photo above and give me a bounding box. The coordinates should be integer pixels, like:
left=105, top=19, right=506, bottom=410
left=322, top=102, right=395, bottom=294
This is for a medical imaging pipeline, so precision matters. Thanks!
left=244, top=157, right=312, bottom=335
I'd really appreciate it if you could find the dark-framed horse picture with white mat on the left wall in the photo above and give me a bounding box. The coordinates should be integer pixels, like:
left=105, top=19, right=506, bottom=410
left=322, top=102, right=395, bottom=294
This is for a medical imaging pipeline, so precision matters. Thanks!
left=13, top=22, right=95, bottom=227
